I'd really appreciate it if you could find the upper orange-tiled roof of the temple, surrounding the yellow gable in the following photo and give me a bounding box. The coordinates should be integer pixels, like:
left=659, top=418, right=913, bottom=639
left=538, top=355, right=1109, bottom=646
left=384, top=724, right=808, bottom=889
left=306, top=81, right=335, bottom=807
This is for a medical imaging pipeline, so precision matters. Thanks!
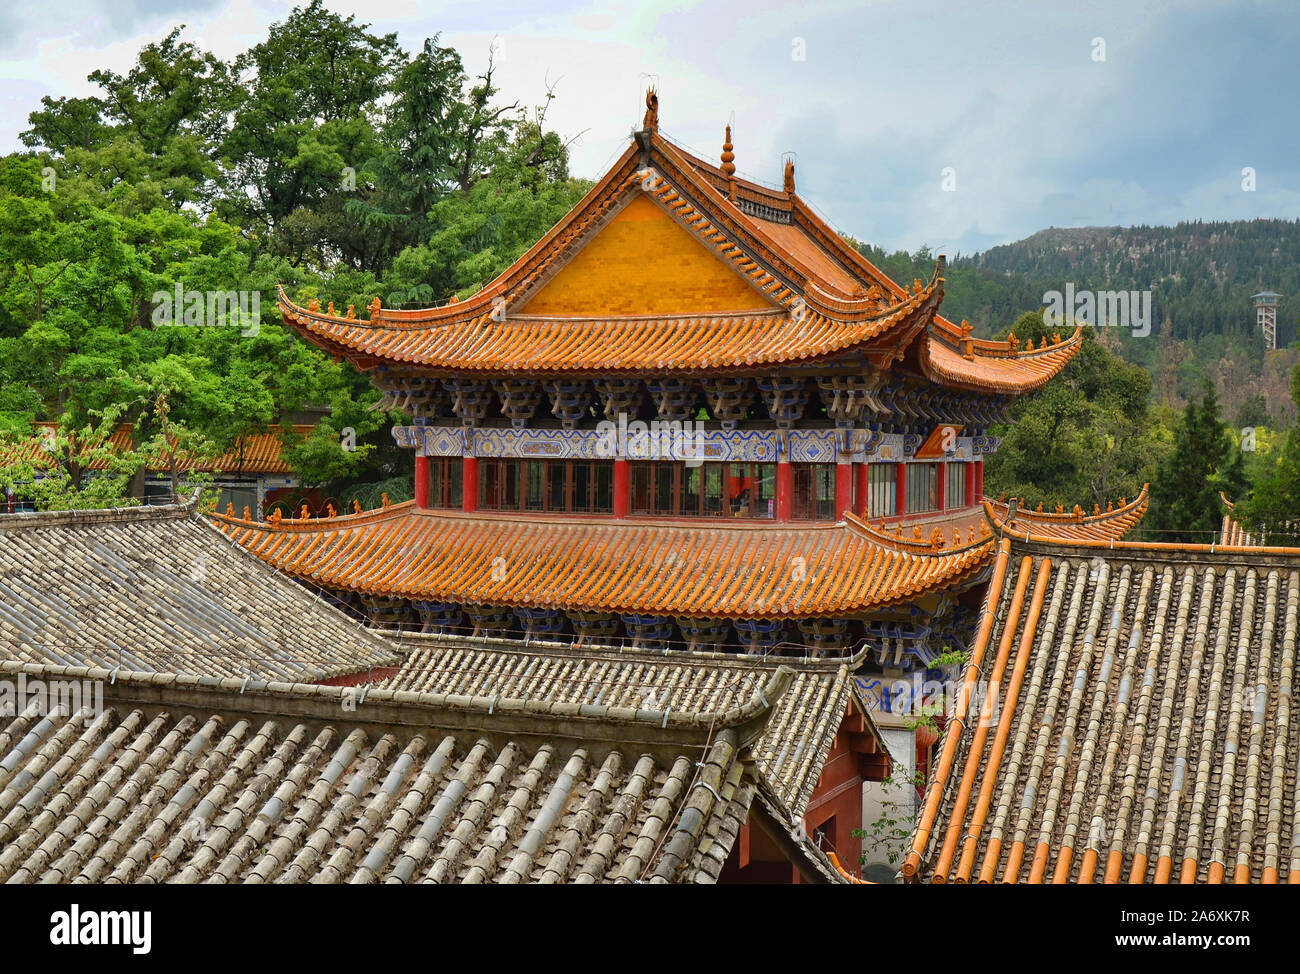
left=280, top=118, right=1075, bottom=393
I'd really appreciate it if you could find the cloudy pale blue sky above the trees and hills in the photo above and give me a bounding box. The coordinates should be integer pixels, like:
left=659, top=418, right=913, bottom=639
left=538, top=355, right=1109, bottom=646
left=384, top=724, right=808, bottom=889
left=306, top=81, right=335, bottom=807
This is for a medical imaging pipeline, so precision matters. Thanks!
left=0, top=0, right=1300, bottom=256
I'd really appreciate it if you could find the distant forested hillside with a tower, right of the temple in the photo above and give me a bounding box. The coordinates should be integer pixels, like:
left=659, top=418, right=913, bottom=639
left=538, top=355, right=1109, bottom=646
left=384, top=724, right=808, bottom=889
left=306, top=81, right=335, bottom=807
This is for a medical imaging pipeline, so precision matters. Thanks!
left=862, top=220, right=1300, bottom=427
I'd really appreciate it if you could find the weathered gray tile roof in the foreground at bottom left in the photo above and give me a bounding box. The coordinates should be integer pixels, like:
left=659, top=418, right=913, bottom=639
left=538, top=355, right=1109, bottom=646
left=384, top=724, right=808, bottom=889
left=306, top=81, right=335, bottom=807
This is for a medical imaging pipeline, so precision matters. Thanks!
left=0, top=662, right=840, bottom=883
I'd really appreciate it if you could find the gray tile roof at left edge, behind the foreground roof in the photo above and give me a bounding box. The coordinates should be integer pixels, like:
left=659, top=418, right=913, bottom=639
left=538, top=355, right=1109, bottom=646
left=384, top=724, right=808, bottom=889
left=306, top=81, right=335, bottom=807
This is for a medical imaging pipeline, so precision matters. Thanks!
left=0, top=502, right=393, bottom=681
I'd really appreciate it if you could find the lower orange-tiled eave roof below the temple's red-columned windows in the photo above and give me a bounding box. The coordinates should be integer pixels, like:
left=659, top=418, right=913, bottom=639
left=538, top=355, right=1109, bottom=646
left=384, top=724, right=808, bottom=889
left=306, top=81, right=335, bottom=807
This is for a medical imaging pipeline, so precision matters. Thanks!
left=215, top=502, right=992, bottom=619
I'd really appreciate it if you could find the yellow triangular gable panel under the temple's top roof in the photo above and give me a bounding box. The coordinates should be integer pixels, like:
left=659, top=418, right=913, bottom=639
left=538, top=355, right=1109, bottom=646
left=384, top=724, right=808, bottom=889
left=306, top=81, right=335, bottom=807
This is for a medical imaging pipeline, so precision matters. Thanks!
left=514, top=194, right=772, bottom=317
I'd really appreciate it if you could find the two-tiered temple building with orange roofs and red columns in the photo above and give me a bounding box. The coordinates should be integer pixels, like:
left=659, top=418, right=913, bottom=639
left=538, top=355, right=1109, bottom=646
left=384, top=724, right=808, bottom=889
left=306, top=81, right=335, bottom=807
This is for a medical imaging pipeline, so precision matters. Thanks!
left=220, top=92, right=1097, bottom=670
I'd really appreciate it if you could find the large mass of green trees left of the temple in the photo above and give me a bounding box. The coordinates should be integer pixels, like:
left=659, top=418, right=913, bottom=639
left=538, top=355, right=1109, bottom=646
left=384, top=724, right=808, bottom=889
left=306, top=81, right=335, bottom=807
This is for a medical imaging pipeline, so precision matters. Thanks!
left=0, top=11, right=574, bottom=506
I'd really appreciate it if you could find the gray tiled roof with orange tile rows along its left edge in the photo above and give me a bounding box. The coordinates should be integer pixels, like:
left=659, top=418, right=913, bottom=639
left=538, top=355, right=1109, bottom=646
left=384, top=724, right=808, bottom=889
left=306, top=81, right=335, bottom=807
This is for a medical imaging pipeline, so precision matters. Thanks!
left=904, top=536, right=1300, bottom=884
